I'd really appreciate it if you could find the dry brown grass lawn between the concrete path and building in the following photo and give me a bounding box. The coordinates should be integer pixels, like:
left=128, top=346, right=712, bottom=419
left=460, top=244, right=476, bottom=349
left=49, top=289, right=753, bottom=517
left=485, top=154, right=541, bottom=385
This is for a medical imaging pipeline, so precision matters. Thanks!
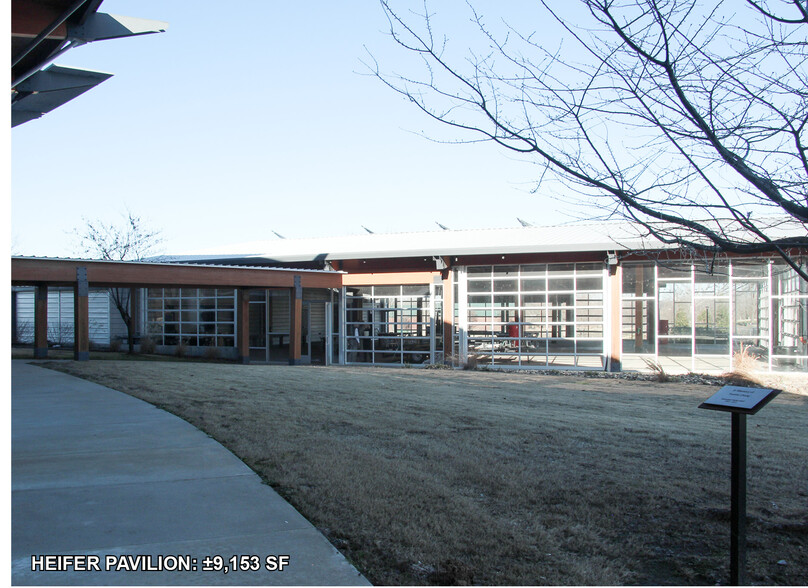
left=34, top=361, right=808, bottom=585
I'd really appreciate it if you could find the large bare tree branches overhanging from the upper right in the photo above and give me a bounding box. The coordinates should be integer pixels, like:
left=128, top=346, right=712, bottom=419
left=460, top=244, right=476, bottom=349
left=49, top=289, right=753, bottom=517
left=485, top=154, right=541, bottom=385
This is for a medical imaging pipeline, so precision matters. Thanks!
left=368, top=0, right=808, bottom=280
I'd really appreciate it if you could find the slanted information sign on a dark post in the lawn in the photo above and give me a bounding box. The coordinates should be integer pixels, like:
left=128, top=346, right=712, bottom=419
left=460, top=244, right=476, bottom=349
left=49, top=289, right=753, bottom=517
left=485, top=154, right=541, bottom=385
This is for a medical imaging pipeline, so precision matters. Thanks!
left=699, top=386, right=780, bottom=586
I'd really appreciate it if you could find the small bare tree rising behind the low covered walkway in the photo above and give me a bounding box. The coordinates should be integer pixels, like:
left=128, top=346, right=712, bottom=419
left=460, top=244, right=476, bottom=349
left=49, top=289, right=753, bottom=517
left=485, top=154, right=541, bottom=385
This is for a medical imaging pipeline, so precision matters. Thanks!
left=75, top=211, right=162, bottom=353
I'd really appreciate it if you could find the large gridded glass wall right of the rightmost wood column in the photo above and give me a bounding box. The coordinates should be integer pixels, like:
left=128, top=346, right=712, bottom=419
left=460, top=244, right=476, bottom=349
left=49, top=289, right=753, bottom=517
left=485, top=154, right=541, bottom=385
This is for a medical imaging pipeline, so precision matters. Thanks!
left=622, top=260, right=808, bottom=371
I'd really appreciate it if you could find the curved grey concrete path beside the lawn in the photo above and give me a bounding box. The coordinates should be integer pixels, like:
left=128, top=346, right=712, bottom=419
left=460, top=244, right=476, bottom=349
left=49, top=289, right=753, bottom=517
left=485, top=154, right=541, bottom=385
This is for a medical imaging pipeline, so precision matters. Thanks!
left=11, top=360, right=369, bottom=585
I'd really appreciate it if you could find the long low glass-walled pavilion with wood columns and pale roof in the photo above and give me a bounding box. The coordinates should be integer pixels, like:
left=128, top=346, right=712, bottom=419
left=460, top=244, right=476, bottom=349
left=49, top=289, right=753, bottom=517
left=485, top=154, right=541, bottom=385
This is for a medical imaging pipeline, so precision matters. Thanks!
left=12, top=224, right=808, bottom=372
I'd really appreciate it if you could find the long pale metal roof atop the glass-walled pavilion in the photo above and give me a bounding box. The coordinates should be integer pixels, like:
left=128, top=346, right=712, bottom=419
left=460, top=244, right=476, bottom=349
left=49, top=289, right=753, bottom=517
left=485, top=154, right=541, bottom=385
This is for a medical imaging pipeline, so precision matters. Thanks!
left=166, top=223, right=663, bottom=263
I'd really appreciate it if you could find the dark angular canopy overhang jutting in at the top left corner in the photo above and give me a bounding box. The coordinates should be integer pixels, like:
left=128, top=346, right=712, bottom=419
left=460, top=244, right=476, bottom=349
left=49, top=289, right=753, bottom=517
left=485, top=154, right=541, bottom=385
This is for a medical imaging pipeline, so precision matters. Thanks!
left=11, top=0, right=168, bottom=127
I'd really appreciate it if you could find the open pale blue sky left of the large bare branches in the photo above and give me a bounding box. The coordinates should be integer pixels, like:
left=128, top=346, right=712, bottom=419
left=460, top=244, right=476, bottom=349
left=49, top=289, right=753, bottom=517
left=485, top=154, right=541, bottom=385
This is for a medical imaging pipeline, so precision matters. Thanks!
left=11, top=0, right=580, bottom=256
